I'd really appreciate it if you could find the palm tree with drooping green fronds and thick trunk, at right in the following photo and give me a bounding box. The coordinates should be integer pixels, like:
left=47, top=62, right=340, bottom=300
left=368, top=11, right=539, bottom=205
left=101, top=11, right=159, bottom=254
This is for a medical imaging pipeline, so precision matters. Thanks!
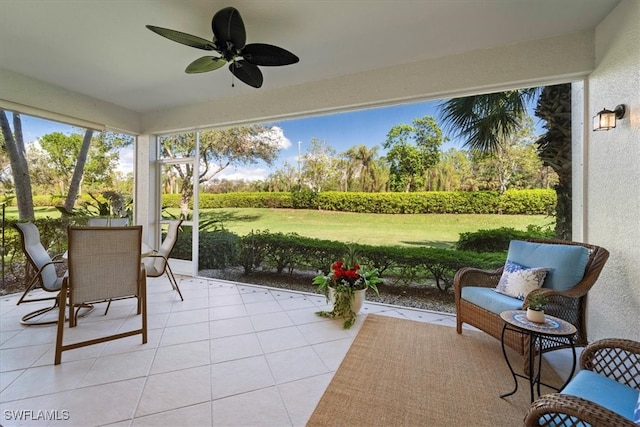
left=440, top=83, right=571, bottom=239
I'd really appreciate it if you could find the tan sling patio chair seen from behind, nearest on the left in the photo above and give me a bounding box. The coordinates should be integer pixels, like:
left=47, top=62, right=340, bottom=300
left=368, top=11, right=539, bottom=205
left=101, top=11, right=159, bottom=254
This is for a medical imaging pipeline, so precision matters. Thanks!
left=55, top=226, right=147, bottom=365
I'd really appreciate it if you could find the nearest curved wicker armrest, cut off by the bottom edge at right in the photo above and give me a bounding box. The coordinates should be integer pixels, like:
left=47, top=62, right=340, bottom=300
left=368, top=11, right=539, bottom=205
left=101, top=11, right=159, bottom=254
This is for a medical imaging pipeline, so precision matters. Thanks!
left=524, top=393, right=637, bottom=427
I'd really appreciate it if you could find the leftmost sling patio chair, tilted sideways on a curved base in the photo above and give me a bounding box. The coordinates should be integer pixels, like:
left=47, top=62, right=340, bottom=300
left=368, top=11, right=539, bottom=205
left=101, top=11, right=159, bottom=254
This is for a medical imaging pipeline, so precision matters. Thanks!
left=15, top=222, right=66, bottom=325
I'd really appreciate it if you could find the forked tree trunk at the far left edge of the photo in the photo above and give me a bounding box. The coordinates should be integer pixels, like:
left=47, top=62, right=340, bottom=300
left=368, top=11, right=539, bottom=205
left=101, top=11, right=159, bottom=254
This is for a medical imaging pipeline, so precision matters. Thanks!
left=0, top=109, right=35, bottom=220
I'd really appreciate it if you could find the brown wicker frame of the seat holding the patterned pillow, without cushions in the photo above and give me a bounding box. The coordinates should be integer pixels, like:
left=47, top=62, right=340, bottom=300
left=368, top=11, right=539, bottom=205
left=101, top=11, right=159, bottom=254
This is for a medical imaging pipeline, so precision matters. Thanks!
left=454, top=239, right=609, bottom=372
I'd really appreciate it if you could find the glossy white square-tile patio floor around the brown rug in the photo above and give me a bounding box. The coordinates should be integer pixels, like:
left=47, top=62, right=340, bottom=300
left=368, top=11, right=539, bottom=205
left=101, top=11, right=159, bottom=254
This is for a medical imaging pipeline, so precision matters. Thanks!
left=0, top=278, right=570, bottom=427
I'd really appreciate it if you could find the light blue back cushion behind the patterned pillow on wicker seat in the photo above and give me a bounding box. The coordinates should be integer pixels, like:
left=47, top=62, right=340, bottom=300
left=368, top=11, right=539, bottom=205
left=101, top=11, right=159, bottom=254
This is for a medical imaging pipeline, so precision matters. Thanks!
left=507, top=240, right=589, bottom=291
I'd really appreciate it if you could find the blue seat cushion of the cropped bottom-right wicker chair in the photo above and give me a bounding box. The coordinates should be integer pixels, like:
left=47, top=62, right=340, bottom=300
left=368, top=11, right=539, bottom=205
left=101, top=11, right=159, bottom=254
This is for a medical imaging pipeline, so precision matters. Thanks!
left=561, top=370, right=639, bottom=421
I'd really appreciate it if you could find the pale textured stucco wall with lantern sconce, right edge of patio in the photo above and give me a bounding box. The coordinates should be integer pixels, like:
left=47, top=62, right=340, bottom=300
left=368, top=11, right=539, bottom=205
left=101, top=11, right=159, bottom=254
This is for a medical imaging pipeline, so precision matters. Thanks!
left=584, top=0, right=640, bottom=340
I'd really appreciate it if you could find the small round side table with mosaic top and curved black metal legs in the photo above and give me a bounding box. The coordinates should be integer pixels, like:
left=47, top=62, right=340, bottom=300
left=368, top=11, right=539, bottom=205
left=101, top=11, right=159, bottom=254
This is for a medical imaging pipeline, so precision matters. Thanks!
left=500, top=310, right=577, bottom=402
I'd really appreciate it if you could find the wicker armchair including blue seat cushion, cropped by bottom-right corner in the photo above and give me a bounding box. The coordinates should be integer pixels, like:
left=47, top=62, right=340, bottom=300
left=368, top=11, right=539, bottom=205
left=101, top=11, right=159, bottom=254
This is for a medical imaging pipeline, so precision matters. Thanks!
left=524, top=338, right=640, bottom=427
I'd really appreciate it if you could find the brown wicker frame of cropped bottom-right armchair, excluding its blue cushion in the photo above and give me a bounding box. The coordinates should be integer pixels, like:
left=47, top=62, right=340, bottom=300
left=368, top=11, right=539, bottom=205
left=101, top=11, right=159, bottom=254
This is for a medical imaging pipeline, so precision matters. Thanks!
left=524, top=339, right=640, bottom=427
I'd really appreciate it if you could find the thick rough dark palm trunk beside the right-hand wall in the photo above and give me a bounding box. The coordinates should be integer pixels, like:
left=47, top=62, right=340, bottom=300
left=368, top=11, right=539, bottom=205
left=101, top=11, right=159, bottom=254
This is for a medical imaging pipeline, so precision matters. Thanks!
left=536, top=83, right=572, bottom=240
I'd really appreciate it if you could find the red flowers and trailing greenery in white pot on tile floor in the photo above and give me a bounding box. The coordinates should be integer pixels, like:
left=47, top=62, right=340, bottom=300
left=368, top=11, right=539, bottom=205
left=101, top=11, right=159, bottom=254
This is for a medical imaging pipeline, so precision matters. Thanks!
left=313, top=260, right=382, bottom=329
